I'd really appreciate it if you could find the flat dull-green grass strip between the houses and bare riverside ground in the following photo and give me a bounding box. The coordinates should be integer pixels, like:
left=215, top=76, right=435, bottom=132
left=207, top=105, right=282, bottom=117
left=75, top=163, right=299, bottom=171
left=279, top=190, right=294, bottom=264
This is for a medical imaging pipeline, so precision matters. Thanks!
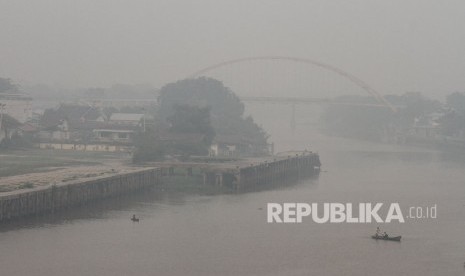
left=0, top=149, right=130, bottom=177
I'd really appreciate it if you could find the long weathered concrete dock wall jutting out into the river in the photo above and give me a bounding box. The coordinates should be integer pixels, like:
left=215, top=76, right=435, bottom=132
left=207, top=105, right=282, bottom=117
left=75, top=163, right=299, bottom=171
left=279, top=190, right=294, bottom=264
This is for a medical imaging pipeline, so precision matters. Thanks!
left=0, top=152, right=321, bottom=222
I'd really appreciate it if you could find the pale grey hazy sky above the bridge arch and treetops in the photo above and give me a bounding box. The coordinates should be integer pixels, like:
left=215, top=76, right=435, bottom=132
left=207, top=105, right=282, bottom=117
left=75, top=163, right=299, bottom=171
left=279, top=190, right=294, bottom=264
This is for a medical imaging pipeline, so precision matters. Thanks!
left=0, top=0, right=465, bottom=97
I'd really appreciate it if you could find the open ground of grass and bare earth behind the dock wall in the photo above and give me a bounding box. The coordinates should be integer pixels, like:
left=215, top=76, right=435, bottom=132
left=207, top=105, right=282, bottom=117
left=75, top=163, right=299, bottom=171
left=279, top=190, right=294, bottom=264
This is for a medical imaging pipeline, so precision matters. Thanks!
left=0, top=149, right=132, bottom=194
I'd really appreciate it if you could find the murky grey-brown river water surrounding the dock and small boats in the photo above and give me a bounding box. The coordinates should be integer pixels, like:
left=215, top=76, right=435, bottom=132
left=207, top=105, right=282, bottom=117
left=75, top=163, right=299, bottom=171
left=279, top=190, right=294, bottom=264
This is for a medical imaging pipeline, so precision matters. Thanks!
left=0, top=129, right=465, bottom=276
